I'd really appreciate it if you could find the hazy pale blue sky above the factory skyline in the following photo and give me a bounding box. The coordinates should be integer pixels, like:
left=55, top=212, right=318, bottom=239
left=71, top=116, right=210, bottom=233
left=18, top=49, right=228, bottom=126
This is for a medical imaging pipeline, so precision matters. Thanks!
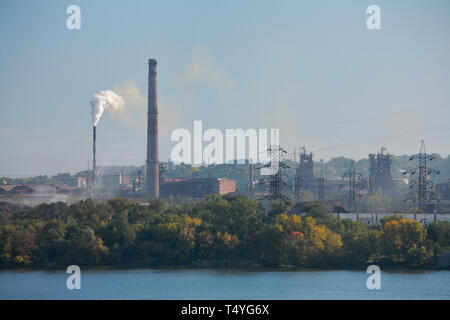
left=0, top=0, right=450, bottom=177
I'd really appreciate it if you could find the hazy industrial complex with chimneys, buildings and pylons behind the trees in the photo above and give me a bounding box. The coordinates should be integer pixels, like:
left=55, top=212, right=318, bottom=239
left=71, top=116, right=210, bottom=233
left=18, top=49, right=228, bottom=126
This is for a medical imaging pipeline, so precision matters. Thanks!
left=0, top=59, right=450, bottom=220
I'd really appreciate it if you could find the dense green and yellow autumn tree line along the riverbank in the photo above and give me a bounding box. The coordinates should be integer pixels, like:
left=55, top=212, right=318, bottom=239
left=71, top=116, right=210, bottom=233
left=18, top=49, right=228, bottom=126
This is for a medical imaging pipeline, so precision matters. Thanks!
left=0, top=195, right=450, bottom=268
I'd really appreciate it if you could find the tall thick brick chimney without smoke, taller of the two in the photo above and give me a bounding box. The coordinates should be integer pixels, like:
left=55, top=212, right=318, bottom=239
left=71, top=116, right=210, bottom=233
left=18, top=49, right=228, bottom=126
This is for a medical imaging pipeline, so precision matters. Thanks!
left=147, top=59, right=159, bottom=198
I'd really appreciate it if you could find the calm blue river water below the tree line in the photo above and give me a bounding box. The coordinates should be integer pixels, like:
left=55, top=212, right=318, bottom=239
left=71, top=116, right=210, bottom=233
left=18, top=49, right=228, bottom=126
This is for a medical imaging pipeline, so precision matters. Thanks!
left=0, top=269, right=450, bottom=300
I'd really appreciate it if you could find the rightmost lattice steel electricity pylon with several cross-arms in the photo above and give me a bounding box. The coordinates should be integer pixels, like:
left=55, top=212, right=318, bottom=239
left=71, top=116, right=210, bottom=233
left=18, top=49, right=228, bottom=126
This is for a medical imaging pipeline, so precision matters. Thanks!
left=403, top=140, right=440, bottom=213
